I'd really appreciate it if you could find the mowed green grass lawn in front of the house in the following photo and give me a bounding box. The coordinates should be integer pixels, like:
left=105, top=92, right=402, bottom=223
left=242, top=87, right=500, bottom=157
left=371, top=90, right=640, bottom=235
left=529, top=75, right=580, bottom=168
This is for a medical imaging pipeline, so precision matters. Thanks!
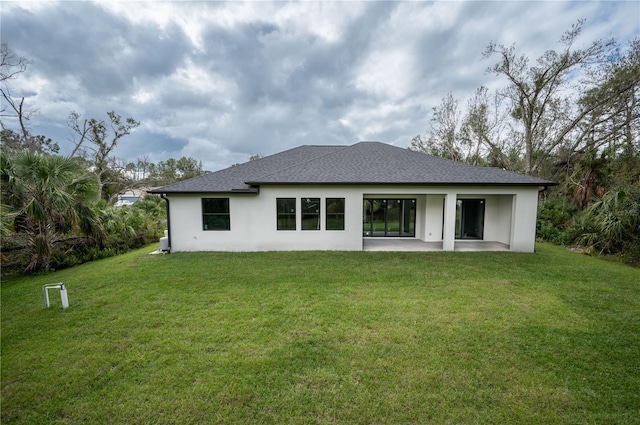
left=1, top=244, right=640, bottom=425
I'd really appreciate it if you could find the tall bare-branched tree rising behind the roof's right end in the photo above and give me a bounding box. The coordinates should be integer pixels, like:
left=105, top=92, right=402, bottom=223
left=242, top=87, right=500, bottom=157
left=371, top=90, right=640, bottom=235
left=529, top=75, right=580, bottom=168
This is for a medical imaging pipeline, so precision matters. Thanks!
left=484, top=20, right=640, bottom=174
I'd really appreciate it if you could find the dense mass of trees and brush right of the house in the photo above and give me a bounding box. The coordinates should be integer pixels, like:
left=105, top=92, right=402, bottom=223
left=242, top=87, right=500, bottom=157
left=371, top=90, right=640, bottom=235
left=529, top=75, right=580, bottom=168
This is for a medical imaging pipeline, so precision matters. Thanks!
left=409, top=21, right=640, bottom=264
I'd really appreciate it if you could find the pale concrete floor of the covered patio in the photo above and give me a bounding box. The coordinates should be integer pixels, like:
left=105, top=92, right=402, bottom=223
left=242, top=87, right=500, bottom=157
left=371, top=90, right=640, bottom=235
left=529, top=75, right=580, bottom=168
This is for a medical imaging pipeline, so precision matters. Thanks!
left=362, top=238, right=509, bottom=252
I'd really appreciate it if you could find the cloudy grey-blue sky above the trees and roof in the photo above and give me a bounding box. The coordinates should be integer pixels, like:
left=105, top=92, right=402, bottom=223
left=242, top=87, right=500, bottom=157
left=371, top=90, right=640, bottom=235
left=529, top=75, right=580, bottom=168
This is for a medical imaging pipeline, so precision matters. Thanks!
left=0, top=0, right=640, bottom=171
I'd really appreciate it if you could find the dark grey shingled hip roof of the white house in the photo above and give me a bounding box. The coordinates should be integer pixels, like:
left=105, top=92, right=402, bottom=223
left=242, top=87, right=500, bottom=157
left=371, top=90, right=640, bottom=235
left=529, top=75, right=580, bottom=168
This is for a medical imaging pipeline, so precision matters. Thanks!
left=153, top=142, right=555, bottom=193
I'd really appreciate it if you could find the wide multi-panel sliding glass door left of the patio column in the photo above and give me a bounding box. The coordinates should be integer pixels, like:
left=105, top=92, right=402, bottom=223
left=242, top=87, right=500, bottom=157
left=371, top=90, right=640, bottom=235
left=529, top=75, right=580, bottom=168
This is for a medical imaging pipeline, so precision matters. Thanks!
left=362, top=198, right=416, bottom=237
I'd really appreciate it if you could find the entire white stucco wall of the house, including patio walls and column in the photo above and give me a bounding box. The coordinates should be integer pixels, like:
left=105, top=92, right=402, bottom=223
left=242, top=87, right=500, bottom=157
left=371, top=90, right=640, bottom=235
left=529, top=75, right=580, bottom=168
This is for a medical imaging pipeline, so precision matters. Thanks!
left=167, top=185, right=538, bottom=252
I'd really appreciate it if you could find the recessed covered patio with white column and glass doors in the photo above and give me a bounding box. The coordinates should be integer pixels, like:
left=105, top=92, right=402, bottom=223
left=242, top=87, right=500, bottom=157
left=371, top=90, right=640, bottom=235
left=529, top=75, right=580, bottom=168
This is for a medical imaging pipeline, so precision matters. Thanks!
left=362, top=186, right=537, bottom=252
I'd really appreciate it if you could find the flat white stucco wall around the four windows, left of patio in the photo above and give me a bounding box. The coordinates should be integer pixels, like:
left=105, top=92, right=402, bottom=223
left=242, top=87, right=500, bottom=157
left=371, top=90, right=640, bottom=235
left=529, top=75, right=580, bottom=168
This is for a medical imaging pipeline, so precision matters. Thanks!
left=167, top=186, right=362, bottom=252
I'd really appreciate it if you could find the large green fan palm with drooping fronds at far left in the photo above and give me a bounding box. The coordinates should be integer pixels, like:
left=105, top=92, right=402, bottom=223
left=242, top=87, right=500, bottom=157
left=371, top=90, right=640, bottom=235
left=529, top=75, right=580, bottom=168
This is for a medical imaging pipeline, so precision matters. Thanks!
left=0, top=152, right=104, bottom=271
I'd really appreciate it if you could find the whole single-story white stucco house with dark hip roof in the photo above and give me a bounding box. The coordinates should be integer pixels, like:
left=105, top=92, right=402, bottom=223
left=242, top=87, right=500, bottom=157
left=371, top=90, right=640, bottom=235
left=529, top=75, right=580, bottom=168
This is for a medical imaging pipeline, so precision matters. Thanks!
left=151, top=142, right=555, bottom=252
